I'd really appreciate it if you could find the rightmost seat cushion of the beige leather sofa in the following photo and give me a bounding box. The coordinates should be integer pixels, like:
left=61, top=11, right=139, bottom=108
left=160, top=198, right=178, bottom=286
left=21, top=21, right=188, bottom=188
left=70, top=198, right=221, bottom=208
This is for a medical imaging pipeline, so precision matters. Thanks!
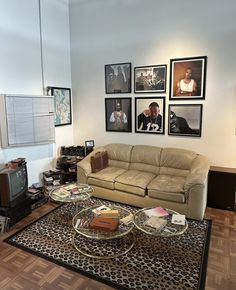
left=147, top=175, right=186, bottom=203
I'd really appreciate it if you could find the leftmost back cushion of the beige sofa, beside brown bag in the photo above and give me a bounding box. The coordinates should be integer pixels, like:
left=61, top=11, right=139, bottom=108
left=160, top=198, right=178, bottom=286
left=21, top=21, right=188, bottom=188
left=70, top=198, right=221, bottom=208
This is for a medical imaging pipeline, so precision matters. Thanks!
left=105, top=144, right=133, bottom=169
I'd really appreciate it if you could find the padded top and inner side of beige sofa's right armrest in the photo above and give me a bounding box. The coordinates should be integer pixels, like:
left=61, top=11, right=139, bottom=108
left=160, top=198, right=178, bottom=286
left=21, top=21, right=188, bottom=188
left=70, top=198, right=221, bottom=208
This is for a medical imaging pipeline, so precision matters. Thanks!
left=184, top=155, right=210, bottom=192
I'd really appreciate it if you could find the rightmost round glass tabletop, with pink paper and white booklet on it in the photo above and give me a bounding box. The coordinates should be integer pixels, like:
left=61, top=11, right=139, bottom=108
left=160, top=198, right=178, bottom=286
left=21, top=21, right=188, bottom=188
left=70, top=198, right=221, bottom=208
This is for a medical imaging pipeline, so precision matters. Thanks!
left=133, top=208, right=188, bottom=237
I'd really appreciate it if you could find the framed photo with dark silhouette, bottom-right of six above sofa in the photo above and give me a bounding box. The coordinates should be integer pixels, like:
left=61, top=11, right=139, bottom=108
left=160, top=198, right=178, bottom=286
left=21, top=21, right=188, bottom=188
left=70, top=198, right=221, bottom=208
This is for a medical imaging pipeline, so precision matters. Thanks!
left=168, top=104, right=202, bottom=137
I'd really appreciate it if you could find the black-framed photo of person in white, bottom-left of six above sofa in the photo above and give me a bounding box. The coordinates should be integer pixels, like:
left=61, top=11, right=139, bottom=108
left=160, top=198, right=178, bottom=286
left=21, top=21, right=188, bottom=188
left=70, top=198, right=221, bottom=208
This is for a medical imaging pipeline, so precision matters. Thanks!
left=105, top=98, right=132, bottom=132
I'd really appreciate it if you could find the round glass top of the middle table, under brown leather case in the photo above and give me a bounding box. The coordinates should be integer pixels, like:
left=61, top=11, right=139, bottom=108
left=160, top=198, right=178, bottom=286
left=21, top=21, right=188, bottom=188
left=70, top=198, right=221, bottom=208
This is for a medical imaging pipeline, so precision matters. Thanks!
left=72, top=205, right=134, bottom=240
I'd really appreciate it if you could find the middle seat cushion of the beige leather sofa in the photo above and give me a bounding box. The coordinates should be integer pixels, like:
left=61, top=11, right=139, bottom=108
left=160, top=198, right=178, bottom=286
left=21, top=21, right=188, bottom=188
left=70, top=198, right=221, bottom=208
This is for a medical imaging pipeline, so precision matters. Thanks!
left=115, top=170, right=156, bottom=196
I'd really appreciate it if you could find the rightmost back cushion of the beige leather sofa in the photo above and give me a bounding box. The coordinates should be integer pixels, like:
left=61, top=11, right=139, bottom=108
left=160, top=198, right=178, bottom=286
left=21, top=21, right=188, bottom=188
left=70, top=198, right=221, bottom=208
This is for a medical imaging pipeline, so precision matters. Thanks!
left=160, top=148, right=197, bottom=176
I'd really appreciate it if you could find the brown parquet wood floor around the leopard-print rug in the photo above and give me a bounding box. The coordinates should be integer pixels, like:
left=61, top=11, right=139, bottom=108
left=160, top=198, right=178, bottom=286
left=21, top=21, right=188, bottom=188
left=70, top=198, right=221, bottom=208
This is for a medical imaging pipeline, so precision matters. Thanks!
left=0, top=202, right=236, bottom=290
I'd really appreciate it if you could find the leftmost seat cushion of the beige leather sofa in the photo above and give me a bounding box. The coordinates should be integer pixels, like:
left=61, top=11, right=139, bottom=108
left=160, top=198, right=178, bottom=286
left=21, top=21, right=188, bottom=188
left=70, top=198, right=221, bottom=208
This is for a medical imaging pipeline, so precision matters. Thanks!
left=88, top=166, right=126, bottom=189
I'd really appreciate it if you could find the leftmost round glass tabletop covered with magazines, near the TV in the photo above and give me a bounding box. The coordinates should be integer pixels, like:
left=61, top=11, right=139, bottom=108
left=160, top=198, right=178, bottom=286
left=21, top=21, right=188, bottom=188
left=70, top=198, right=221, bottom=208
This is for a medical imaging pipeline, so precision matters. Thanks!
left=49, top=182, right=93, bottom=202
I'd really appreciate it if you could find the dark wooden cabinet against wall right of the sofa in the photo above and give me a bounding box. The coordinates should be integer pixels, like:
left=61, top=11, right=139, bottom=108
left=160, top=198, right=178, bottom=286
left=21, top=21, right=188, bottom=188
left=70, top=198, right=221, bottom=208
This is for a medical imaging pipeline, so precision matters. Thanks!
left=207, top=166, right=236, bottom=210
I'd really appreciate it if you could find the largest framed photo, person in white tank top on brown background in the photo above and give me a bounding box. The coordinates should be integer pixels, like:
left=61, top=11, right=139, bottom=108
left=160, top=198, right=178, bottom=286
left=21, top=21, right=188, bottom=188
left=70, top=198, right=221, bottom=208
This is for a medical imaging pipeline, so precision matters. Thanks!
left=170, top=56, right=207, bottom=100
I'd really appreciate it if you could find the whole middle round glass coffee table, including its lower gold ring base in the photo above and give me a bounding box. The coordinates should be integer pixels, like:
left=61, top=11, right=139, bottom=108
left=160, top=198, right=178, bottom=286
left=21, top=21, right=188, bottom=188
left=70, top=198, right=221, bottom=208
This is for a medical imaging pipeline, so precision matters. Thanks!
left=72, top=205, right=135, bottom=259
